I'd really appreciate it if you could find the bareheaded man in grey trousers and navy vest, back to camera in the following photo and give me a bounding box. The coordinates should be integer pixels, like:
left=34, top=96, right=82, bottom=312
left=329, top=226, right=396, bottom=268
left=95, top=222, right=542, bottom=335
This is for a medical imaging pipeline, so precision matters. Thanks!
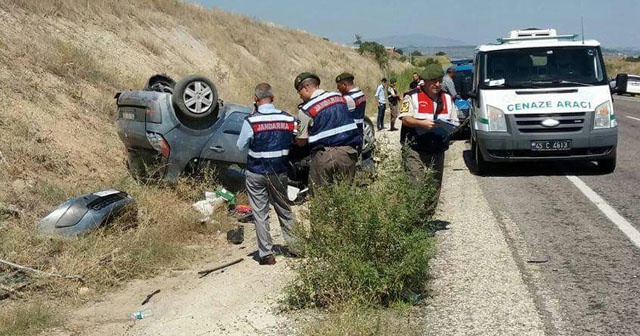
left=237, top=83, right=296, bottom=265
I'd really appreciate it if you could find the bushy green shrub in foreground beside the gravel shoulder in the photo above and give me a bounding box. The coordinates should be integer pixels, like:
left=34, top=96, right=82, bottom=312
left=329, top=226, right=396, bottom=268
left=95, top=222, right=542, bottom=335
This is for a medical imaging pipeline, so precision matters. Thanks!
left=286, top=164, right=434, bottom=308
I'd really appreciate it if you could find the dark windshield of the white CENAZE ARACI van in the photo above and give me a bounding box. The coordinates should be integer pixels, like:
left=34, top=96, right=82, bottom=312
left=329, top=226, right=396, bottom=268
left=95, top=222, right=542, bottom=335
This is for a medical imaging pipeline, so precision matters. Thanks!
left=480, top=47, right=607, bottom=89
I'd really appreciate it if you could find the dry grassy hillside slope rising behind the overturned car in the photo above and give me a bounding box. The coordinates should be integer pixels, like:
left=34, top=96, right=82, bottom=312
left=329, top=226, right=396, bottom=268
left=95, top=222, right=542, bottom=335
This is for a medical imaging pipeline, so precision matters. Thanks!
left=0, top=0, right=398, bottom=213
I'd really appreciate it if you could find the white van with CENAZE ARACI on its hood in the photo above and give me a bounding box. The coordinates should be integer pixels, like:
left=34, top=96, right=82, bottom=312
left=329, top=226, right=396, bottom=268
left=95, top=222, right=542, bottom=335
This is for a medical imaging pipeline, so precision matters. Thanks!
left=470, top=29, right=618, bottom=174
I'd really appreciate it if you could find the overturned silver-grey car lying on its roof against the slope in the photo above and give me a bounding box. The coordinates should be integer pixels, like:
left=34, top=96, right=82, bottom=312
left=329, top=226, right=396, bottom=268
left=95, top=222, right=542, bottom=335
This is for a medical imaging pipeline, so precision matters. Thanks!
left=116, top=75, right=375, bottom=190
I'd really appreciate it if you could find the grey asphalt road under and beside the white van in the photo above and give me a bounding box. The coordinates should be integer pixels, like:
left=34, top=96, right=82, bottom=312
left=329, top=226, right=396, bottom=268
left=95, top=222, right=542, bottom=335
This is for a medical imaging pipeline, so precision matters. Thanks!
left=464, top=96, right=640, bottom=335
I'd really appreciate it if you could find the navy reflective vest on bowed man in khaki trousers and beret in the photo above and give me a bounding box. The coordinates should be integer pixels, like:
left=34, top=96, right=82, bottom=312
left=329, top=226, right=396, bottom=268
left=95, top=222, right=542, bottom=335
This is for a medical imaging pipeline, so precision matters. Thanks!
left=300, top=91, right=362, bottom=150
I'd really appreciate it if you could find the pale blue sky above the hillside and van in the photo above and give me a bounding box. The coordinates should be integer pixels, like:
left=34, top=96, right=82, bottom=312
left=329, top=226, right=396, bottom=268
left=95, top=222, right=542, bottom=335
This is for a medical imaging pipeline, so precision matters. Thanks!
left=194, top=0, right=640, bottom=49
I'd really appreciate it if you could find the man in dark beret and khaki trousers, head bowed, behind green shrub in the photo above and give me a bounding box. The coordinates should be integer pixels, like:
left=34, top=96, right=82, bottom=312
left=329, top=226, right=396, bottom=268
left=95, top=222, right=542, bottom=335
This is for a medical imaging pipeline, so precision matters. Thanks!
left=293, top=72, right=362, bottom=187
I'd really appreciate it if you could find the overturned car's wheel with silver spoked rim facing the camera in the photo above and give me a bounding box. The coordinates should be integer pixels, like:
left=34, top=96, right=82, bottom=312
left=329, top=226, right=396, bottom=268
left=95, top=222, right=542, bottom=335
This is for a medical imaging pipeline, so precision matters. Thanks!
left=171, top=75, right=218, bottom=119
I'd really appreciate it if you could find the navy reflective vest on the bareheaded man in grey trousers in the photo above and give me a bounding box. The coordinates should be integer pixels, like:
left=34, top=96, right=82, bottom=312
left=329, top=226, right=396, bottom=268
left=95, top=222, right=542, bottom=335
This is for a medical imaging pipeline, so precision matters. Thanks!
left=246, top=111, right=295, bottom=174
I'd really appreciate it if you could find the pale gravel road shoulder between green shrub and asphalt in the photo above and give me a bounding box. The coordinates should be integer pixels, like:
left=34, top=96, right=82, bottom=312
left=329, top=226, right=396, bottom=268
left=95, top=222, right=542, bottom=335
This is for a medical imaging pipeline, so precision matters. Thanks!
left=424, top=141, right=544, bottom=335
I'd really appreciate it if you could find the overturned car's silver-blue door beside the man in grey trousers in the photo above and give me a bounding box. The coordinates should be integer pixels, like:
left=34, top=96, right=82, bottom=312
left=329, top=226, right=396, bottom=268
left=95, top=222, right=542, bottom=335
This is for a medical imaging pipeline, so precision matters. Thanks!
left=200, top=111, right=248, bottom=165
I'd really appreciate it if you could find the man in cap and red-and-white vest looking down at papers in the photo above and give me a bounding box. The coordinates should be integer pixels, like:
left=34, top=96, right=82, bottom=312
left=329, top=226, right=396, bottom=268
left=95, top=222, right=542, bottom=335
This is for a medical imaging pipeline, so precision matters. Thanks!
left=398, top=64, right=457, bottom=197
